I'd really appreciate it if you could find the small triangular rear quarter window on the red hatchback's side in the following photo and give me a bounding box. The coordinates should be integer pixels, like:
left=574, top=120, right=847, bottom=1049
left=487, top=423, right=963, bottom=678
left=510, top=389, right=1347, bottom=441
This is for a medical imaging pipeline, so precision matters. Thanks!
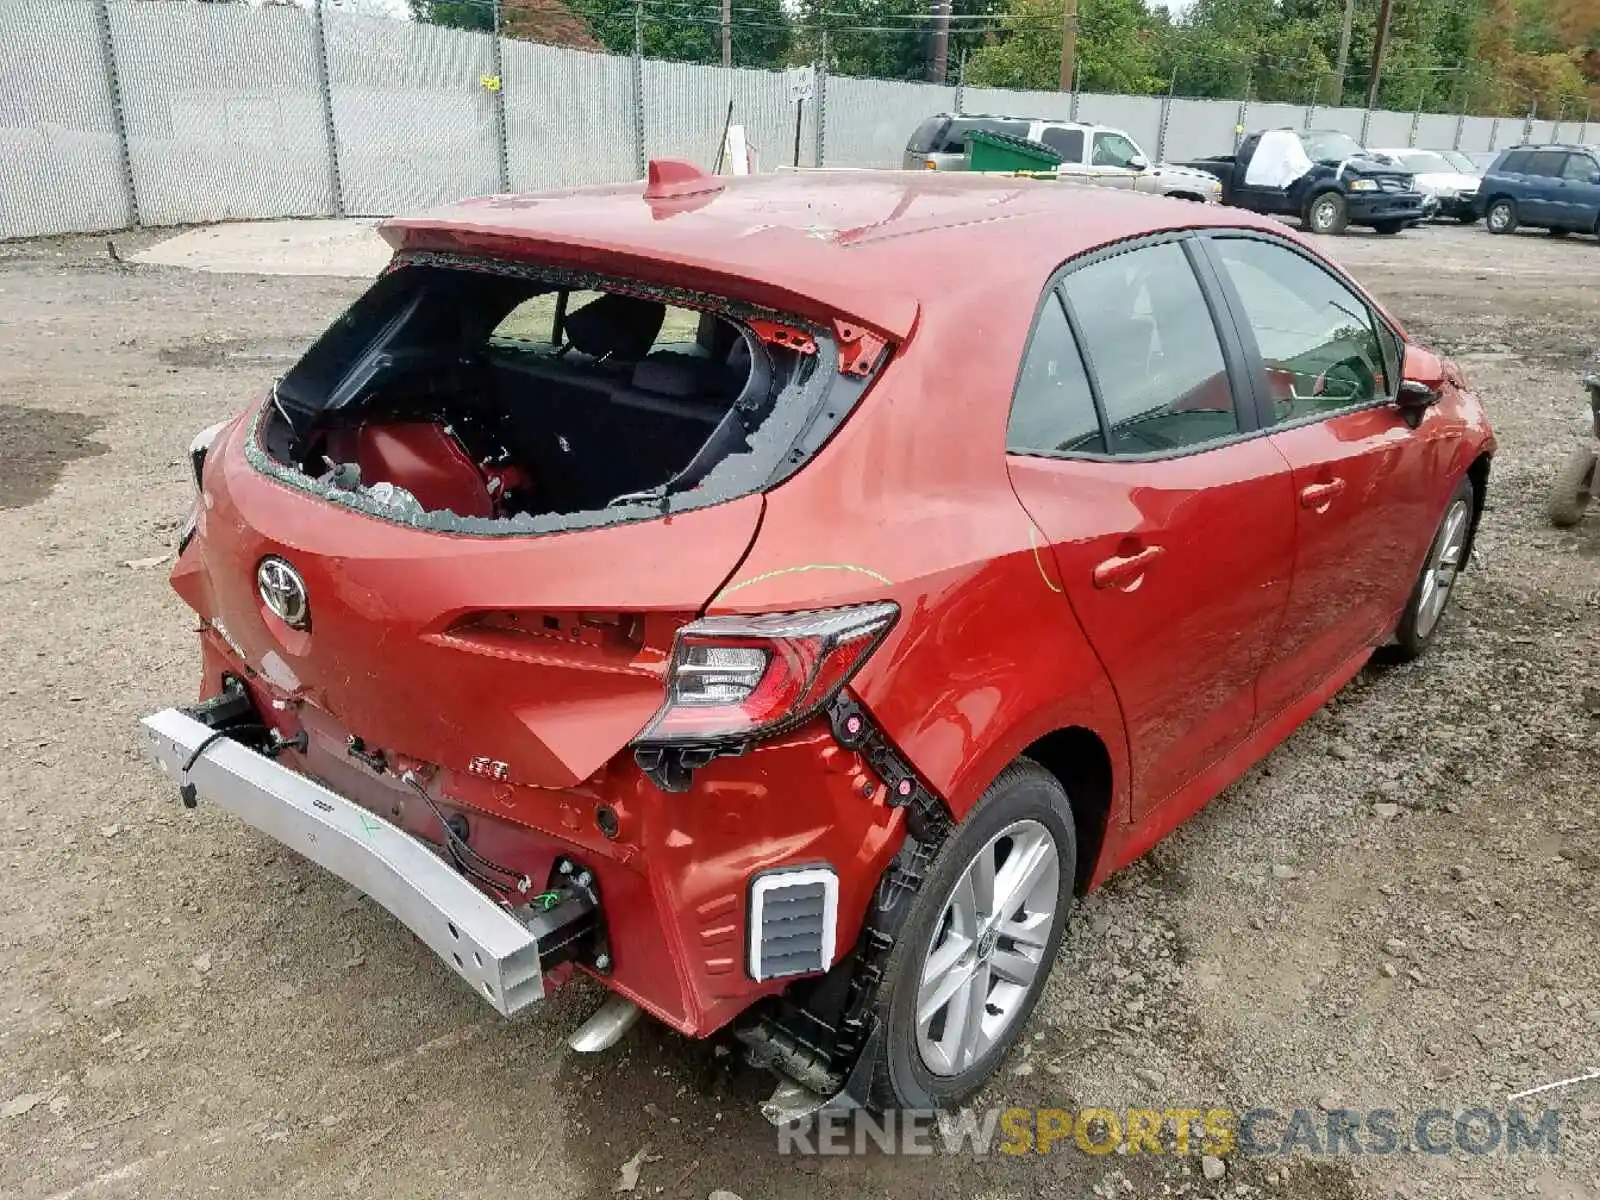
left=1006, top=293, right=1106, bottom=454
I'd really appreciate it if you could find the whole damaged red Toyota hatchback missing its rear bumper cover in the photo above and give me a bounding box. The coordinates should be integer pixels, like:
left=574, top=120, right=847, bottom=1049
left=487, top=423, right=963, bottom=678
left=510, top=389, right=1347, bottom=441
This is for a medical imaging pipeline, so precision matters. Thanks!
left=144, top=163, right=1494, bottom=1112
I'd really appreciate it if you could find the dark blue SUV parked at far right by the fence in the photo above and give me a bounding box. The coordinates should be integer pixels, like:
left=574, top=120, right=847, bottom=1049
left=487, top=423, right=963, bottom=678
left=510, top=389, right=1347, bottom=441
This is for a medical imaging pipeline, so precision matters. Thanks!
left=1477, top=146, right=1600, bottom=235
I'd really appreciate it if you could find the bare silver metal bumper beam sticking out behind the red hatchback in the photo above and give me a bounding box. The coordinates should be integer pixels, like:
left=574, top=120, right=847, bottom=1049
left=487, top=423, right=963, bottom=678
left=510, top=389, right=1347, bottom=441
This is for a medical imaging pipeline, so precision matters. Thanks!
left=141, top=709, right=544, bottom=1016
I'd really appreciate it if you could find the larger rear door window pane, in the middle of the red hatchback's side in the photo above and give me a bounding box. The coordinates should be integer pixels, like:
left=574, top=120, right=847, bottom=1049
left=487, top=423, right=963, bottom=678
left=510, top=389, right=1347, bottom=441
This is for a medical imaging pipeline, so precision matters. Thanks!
left=1062, top=242, right=1238, bottom=454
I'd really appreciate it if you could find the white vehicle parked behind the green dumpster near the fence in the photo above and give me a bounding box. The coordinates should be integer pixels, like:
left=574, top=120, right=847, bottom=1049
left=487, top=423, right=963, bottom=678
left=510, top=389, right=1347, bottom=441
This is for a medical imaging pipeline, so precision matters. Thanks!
left=902, top=114, right=1222, bottom=203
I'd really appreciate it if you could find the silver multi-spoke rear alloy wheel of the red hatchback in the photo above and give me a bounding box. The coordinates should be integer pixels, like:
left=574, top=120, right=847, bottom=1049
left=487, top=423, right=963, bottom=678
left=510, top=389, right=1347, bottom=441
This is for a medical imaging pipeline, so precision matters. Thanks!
left=917, top=821, right=1061, bottom=1075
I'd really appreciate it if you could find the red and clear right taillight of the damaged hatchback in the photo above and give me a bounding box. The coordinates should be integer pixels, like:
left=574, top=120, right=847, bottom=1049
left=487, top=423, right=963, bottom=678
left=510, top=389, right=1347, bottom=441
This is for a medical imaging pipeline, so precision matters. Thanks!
left=634, top=602, right=899, bottom=746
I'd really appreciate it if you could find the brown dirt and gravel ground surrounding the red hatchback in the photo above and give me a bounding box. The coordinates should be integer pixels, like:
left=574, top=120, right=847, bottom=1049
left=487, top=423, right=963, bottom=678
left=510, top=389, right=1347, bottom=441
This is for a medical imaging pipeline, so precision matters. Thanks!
left=0, top=219, right=1600, bottom=1200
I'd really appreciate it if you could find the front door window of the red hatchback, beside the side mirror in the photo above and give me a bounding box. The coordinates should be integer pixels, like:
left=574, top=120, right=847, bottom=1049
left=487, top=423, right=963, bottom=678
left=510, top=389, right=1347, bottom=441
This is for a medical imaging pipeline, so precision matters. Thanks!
left=1211, top=238, right=1398, bottom=424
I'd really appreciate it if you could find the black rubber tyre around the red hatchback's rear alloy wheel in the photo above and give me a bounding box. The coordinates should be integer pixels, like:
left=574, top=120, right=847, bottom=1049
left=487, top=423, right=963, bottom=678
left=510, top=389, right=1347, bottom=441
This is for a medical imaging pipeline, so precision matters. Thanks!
left=858, top=758, right=1078, bottom=1110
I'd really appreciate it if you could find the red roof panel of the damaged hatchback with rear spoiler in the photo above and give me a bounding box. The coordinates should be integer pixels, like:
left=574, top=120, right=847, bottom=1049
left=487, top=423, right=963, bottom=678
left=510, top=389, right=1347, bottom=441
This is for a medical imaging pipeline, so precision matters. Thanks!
left=381, top=165, right=1283, bottom=338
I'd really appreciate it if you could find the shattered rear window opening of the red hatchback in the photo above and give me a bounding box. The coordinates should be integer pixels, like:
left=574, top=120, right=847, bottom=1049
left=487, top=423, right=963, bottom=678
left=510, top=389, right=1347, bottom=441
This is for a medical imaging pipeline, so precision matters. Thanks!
left=251, top=253, right=870, bottom=534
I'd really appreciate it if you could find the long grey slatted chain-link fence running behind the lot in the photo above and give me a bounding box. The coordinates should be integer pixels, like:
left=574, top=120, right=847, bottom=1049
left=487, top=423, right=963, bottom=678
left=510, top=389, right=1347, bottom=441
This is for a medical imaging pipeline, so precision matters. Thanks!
left=0, top=0, right=1590, bottom=238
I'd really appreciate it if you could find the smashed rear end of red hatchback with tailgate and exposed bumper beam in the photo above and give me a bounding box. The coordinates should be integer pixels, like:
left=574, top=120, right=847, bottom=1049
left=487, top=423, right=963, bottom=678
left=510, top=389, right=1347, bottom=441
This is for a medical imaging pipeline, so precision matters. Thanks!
left=154, top=192, right=904, bottom=1035
